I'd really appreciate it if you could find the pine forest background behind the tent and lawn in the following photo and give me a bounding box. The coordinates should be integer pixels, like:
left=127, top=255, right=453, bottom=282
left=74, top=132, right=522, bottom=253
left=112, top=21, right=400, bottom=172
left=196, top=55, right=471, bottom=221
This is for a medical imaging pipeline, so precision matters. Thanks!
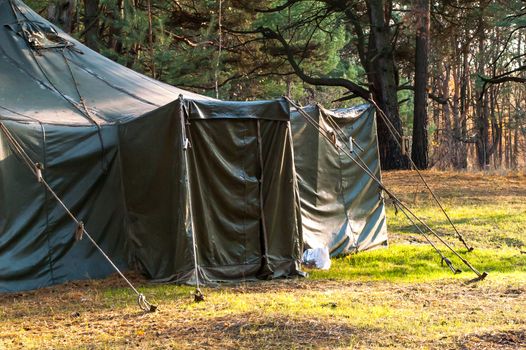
left=27, top=0, right=526, bottom=170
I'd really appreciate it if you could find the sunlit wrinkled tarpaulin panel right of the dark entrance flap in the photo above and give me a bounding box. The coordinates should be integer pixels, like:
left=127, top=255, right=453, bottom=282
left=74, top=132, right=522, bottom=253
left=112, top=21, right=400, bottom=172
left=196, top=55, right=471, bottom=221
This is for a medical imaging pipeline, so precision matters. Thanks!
left=291, top=105, right=387, bottom=256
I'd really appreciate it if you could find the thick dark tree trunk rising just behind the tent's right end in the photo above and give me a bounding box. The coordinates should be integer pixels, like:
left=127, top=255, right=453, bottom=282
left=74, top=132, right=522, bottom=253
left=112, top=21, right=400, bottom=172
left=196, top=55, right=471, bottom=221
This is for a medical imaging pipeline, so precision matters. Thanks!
left=367, top=0, right=407, bottom=170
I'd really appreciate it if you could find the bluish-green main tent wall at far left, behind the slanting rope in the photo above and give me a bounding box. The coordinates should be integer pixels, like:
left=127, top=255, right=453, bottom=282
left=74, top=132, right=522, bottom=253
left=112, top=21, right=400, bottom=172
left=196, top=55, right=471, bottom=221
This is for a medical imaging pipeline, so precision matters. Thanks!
left=0, top=121, right=126, bottom=291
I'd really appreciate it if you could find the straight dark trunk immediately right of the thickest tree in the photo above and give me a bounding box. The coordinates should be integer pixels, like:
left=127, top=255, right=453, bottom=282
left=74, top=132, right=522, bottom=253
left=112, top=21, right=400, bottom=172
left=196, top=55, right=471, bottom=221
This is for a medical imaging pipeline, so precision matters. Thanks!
left=411, top=0, right=430, bottom=169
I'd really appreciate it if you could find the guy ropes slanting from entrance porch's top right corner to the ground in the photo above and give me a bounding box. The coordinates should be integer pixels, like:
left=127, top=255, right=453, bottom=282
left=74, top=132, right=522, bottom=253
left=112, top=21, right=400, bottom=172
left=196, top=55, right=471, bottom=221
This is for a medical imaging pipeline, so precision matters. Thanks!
left=284, top=96, right=487, bottom=280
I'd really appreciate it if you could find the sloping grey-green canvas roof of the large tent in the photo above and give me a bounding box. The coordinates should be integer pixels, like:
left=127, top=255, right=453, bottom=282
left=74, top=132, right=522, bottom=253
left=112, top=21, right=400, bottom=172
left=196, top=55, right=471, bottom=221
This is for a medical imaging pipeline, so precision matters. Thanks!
left=0, top=0, right=210, bottom=125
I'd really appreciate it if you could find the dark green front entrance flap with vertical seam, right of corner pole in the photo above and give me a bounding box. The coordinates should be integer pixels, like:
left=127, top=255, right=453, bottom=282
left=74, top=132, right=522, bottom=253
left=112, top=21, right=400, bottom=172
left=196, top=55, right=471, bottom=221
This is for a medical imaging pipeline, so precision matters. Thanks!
left=187, top=101, right=302, bottom=281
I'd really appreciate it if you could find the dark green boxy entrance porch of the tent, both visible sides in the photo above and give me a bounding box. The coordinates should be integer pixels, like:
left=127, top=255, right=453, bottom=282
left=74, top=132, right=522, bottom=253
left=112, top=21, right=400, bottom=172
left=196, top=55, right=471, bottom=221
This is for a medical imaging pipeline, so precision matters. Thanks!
left=119, top=99, right=303, bottom=283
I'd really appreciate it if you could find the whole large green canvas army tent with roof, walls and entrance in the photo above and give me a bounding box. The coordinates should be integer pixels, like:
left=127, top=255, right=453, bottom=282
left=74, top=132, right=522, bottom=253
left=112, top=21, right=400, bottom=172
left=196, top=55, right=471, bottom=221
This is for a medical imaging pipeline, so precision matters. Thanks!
left=0, top=0, right=387, bottom=291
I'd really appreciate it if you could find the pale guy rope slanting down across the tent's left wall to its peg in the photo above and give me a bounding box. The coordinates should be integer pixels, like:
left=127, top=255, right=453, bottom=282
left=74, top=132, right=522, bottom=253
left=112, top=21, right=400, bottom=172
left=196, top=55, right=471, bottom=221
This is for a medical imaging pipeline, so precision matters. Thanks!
left=0, top=121, right=157, bottom=312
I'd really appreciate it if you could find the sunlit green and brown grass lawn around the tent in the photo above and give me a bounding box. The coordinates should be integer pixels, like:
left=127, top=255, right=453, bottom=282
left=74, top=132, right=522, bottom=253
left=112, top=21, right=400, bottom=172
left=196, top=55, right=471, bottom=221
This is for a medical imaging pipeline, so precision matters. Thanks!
left=0, top=172, right=526, bottom=349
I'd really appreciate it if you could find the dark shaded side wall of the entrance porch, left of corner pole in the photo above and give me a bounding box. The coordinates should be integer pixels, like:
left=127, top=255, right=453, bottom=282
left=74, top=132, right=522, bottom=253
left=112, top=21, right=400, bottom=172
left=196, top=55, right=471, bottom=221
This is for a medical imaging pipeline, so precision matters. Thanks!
left=119, top=100, right=194, bottom=281
